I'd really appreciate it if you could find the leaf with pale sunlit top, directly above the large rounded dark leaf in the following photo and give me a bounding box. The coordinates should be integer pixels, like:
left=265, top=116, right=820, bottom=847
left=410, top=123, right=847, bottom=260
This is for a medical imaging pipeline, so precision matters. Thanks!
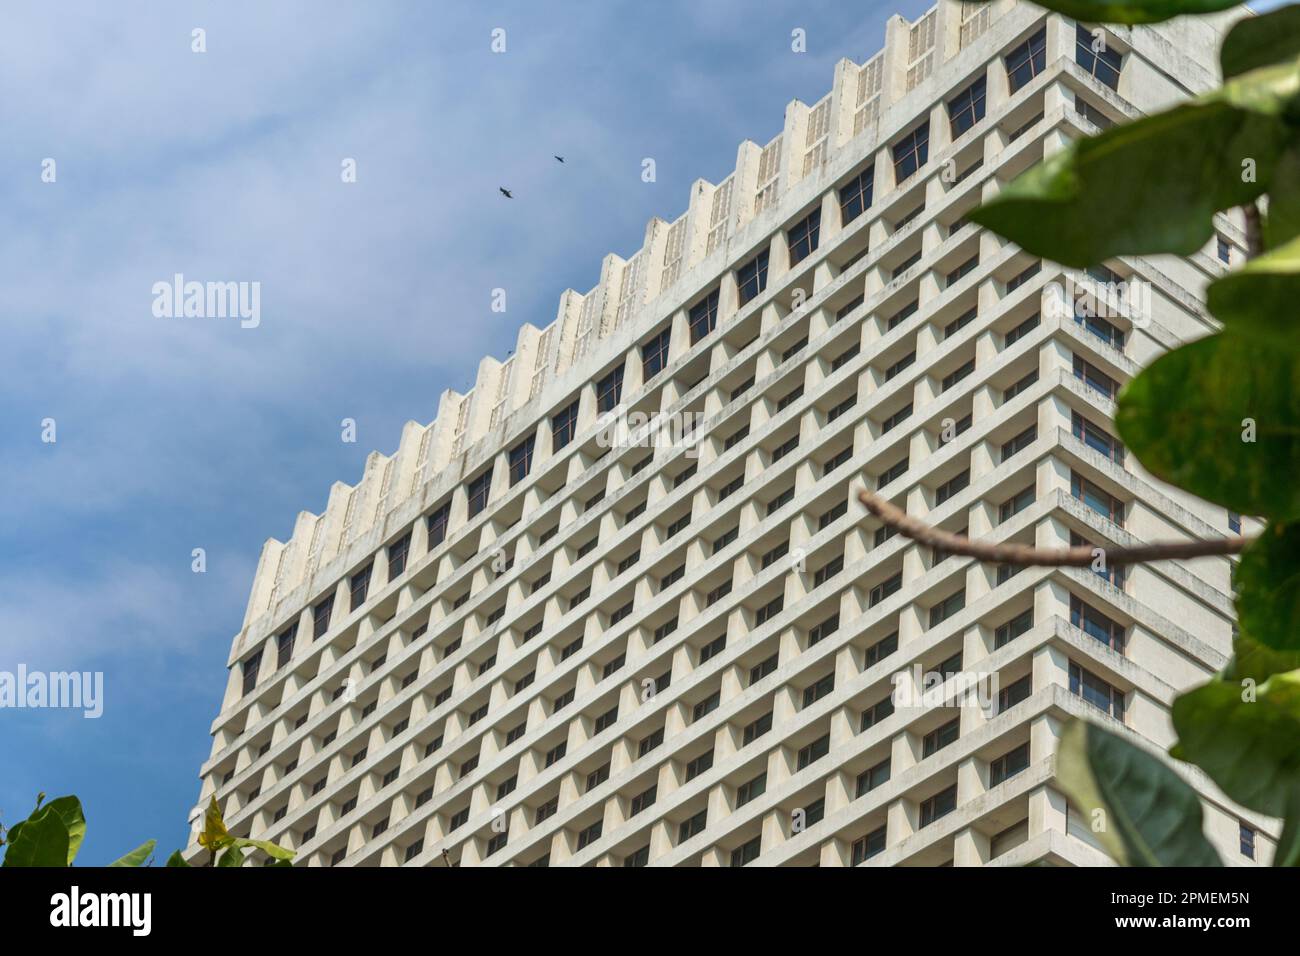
left=1206, top=235, right=1300, bottom=350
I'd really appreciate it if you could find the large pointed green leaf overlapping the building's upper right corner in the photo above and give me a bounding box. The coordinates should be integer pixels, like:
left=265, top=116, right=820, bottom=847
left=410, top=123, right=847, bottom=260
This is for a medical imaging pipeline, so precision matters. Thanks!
left=969, top=61, right=1300, bottom=268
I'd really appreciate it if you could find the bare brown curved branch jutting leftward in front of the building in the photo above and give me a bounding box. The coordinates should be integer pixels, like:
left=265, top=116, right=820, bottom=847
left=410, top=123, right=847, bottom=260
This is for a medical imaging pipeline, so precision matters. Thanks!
left=858, top=488, right=1252, bottom=567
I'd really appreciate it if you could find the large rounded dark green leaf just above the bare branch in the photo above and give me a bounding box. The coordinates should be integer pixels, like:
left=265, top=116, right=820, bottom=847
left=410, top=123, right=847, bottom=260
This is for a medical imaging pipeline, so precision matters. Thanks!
left=1115, top=333, right=1300, bottom=519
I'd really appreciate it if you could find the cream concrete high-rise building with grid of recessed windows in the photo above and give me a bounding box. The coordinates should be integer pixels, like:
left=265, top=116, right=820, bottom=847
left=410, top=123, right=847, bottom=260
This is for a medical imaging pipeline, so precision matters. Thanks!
left=191, top=0, right=1277, bottom=866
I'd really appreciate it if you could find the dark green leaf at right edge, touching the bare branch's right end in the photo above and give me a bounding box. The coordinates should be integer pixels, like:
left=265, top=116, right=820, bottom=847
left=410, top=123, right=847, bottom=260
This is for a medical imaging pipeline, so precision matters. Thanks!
left=1234, top=522, right=1300, bottom=650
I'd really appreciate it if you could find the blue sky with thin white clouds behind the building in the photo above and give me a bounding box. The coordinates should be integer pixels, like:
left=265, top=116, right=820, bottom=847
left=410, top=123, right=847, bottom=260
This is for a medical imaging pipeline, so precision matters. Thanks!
left=0, top=0, right=928, bottom=864
